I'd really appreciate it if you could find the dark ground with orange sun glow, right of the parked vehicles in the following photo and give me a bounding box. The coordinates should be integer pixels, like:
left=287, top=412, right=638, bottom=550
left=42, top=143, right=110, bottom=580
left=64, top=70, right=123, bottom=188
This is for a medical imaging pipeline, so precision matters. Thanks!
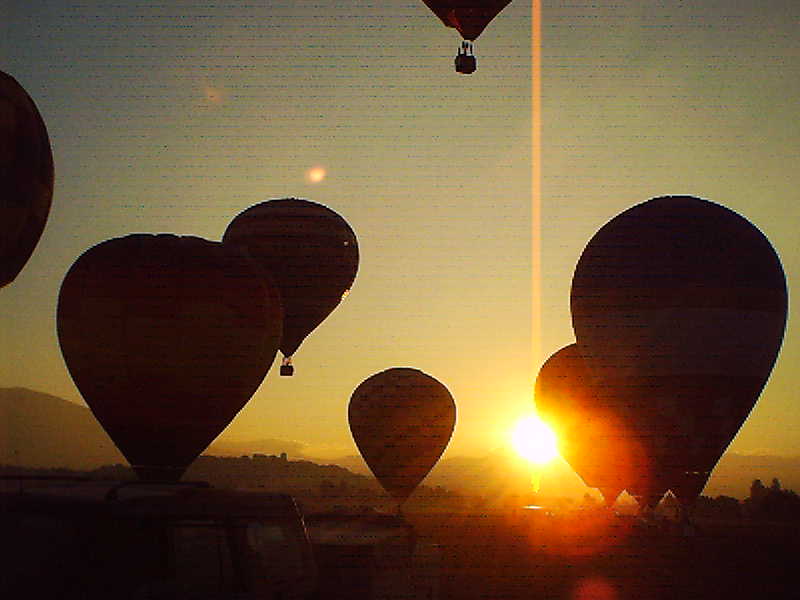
left=410, top=515, right=800, bottom=600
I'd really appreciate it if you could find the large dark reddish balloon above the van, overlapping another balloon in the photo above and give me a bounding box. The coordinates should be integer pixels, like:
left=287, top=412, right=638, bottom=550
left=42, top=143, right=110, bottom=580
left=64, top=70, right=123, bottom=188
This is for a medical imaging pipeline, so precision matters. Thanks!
left=57, top=234, right=283, bottom=480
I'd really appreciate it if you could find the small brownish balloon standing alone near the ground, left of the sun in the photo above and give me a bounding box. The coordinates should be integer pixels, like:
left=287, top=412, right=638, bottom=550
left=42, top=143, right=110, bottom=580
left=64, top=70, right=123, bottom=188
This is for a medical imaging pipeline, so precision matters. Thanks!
left=348, top=368, right=456, bottom=510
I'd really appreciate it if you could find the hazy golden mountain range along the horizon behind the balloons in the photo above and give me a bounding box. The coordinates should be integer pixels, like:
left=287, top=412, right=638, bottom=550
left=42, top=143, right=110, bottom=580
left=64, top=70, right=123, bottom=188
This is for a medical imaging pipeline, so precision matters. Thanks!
left=0, top=388, right=800, bottom=498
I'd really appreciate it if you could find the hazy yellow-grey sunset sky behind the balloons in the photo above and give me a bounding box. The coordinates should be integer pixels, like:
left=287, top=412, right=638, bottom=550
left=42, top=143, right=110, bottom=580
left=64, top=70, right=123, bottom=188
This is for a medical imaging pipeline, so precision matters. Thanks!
left=0, top=0, right=800, bottom=478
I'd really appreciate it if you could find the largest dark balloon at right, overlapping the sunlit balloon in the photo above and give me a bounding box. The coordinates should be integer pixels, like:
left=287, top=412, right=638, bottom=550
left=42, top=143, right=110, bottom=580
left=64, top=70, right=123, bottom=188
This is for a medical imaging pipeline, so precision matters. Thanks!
left=570, top=196, right=787, bottom=505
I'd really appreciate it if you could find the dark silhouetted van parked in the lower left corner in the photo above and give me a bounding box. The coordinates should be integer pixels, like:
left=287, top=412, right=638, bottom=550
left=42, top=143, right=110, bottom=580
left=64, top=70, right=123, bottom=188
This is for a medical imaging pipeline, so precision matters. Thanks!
left=0, top=478, right=316, bottom=600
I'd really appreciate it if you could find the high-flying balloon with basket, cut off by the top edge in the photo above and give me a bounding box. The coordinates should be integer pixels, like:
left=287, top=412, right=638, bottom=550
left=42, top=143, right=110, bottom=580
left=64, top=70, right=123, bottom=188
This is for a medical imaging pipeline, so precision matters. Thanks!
left=423, top=0, right=511, bottom=75
